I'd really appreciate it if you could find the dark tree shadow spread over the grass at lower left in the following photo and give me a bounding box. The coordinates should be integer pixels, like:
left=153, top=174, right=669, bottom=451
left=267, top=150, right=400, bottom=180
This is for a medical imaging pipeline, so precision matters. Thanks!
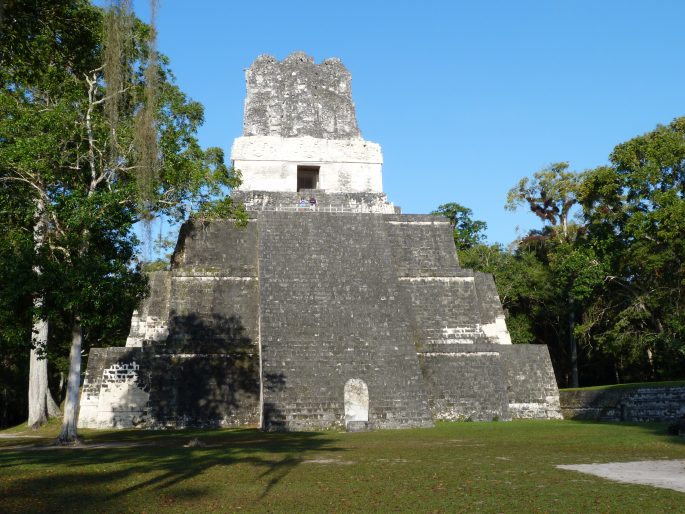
left=0, top=430, right=343, bottom=512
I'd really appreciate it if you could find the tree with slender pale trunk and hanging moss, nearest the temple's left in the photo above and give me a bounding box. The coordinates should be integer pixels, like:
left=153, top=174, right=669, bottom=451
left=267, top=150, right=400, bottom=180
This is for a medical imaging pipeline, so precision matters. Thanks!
left=0, top=0, right=244, bottom=442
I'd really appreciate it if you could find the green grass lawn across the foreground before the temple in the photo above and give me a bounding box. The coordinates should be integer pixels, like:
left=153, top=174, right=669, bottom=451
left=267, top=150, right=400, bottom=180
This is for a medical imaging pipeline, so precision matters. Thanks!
left=0, top=421, right=685, bottom=513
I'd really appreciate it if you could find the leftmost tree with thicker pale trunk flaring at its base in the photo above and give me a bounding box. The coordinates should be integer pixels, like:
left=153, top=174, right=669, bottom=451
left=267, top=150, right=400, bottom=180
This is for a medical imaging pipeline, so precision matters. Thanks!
left=0, top=0, right=101, bottom=427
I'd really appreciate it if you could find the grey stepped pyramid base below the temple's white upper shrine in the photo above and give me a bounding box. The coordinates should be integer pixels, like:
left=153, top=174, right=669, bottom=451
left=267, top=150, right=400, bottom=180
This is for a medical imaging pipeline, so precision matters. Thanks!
left=80, top=208, right=559, bottom=430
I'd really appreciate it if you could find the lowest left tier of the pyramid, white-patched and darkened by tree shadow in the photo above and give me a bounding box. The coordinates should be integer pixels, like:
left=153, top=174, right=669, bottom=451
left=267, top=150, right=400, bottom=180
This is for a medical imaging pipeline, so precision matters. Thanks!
left=79, top=344, right=260, bottom=428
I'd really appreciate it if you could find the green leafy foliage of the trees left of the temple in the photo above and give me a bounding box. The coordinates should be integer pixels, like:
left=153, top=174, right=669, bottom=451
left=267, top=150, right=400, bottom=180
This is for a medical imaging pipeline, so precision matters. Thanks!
left=0, top=0, right=245, bottom=423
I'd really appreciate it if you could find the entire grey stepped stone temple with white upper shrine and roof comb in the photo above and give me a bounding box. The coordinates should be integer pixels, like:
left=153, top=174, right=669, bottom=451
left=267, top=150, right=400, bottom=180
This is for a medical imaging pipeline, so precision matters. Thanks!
left=79, top=53, right=561, bottom=430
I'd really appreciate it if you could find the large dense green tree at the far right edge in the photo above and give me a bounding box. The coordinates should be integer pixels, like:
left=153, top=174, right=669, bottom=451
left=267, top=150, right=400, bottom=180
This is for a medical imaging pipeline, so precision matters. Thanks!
left=579, top=118, right=685, bottom=380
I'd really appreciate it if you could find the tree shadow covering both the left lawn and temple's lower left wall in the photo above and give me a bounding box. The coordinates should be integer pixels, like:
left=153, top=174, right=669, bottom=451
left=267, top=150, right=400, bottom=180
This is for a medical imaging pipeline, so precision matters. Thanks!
left=0, top=308, right=341, bottom=512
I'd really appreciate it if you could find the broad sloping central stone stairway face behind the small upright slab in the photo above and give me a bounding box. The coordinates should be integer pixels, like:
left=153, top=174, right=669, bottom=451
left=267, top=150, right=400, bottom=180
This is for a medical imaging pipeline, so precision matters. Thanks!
left=259, top=212, right=432, bottom=430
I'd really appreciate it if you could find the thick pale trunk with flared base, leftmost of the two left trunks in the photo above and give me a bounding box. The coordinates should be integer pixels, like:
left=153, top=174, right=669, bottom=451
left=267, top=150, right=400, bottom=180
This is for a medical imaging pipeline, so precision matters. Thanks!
left=28, top=198, right=60, bottom=429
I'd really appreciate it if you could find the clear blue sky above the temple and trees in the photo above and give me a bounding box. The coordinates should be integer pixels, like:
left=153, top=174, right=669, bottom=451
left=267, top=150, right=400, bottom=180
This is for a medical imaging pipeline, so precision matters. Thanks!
left=125, top=0, right=685, bottom=248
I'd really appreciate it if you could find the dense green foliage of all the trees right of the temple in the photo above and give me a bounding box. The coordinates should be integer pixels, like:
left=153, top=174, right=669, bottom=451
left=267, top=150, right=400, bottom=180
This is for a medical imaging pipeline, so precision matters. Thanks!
left=480, top=114, right=685, bottom=384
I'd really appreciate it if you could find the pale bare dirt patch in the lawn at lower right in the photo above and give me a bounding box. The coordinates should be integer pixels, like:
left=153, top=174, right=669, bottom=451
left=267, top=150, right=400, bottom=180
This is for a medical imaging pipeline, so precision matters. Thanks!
left=557, top=460, right=685, bottom=493
